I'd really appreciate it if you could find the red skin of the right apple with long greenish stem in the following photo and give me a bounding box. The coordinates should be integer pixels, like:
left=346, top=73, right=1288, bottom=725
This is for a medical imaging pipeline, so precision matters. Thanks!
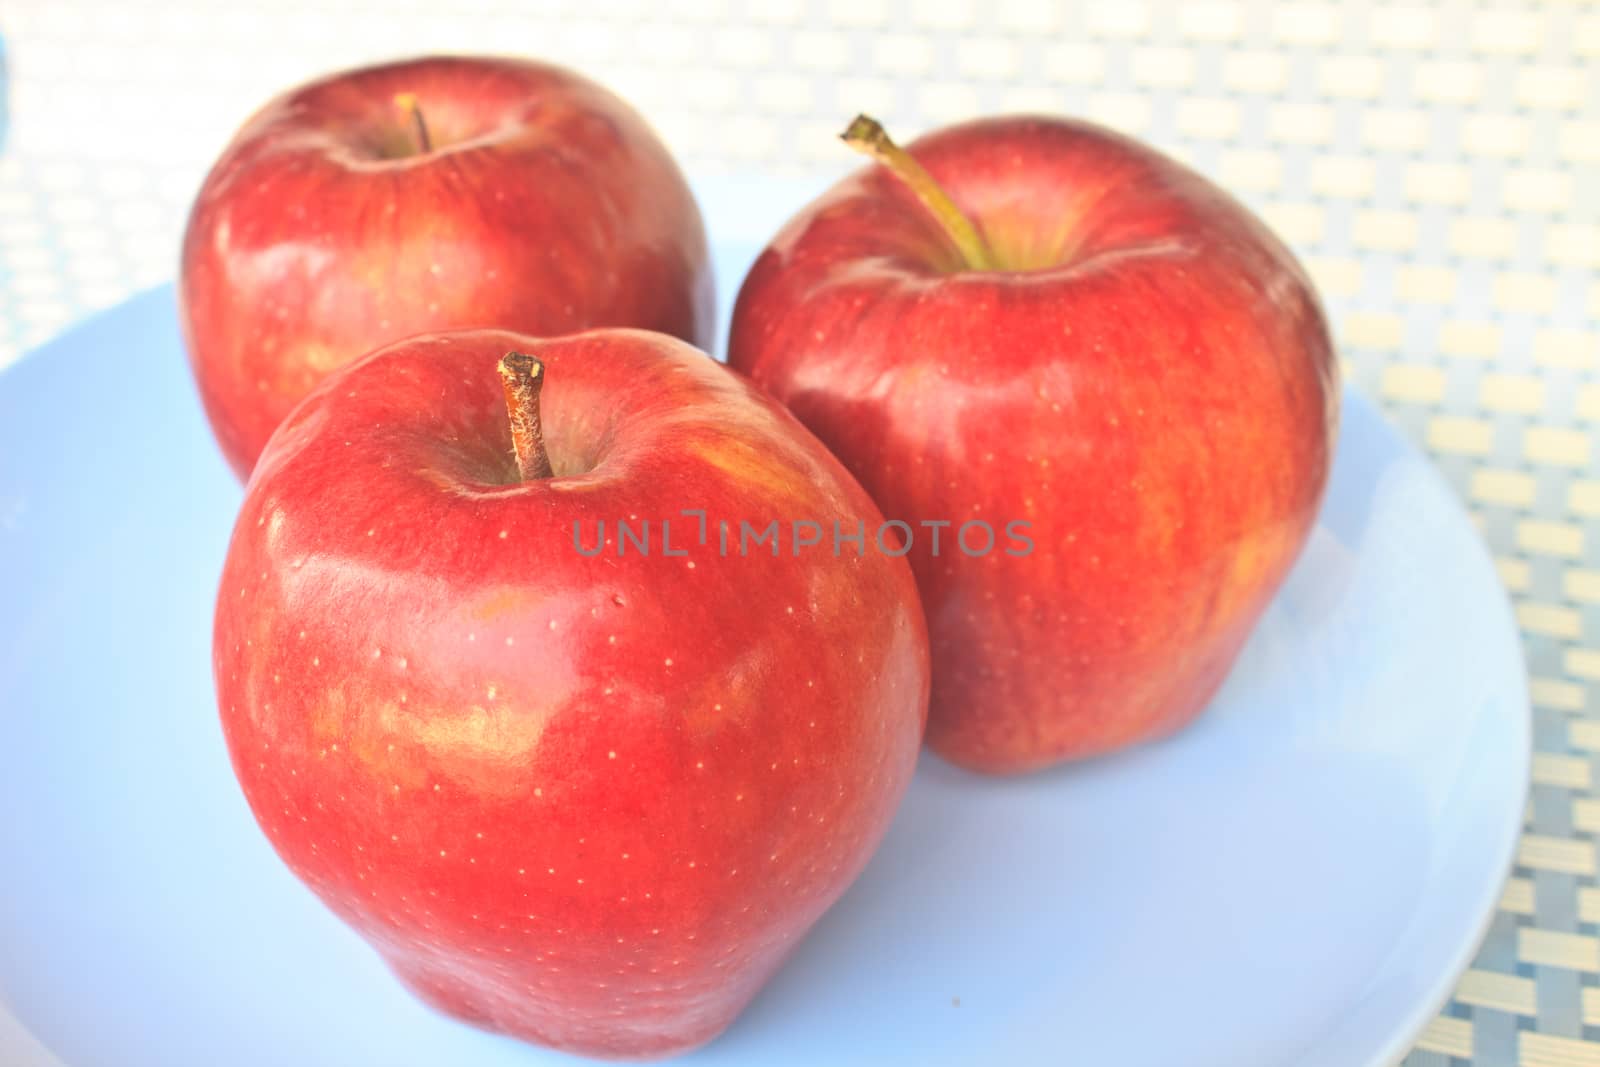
left=730, top=117, right=1339, bottom=773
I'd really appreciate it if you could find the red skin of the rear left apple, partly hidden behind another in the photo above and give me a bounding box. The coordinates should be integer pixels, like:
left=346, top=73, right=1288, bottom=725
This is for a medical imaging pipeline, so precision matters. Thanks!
left=178, top=56, right=714, bottom=478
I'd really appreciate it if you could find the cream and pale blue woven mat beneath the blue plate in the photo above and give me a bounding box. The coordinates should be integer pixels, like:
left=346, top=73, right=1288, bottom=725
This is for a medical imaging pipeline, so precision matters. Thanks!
left=0, top=0, right=1600, bottom=1067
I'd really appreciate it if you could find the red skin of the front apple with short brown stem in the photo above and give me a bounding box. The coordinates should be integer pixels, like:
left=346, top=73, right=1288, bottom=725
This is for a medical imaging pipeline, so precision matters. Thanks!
left=214, top=330, right=928, bottom=1057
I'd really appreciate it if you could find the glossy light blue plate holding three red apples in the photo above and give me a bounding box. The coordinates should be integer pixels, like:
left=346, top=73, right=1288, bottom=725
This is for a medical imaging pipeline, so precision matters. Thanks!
left=0, top=211, right=1530, bottom=1067
